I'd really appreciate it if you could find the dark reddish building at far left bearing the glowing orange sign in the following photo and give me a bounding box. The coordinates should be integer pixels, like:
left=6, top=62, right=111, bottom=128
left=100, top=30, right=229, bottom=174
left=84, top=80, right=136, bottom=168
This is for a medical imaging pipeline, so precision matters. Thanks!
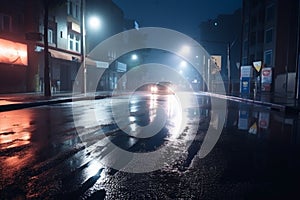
left=0, top=0, right=33, bottom=93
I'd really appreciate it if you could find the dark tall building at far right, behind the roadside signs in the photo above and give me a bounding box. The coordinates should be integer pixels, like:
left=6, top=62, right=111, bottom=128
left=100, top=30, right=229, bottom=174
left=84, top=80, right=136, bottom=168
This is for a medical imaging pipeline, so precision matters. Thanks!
left=241, top=0, right=300, bottom=96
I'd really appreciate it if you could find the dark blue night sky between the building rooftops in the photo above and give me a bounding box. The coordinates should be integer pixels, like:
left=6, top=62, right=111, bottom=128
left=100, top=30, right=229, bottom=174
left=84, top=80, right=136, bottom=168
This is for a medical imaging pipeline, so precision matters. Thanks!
left=113, top=0, right=242, bottom=38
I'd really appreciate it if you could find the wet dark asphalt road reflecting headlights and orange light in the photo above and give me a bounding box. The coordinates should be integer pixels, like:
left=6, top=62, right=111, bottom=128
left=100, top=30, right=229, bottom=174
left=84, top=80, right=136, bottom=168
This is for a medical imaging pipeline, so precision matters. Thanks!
left=0, top=95, right=300, bottom=199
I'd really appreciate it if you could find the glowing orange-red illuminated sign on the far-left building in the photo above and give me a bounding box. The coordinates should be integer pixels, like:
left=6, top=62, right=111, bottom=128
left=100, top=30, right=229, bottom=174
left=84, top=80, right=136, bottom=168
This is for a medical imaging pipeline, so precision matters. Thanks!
left=0, top=39, right=28, bottom=65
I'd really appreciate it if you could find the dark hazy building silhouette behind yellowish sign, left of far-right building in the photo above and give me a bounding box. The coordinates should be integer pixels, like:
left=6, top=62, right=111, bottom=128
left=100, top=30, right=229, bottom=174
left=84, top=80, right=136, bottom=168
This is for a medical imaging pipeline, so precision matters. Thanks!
left=199, top=9, right=242, bottom=91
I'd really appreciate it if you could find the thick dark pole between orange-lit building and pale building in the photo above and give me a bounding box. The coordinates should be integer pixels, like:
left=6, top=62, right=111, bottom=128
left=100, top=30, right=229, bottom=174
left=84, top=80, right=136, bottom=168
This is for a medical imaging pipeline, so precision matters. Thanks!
left=44, top=0, right=51, bottom=97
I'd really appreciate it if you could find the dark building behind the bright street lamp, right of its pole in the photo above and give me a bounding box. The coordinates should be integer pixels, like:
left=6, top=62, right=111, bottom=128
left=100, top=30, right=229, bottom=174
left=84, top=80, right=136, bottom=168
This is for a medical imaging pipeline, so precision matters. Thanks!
left=86, top=0, right=125, bottom=91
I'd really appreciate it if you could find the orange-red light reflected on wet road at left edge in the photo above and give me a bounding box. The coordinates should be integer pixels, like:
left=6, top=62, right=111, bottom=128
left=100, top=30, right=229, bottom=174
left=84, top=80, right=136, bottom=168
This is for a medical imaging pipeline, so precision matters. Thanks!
left=0, top=109, right=35, bottom=182
